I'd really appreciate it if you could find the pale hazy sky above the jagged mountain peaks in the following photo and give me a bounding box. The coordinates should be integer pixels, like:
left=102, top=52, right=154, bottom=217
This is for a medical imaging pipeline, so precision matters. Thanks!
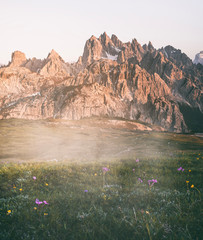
left=0, top=0, right=203, bottom=63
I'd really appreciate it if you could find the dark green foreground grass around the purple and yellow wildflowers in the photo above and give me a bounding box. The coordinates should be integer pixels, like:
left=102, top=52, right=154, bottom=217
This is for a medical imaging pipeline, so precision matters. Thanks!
left=0, top=151, right=203, bottom=240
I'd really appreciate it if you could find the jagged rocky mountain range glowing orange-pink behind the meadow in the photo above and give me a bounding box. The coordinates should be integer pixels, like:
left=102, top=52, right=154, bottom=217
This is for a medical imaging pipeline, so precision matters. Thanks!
left=0, top=33, right=203, bottom=132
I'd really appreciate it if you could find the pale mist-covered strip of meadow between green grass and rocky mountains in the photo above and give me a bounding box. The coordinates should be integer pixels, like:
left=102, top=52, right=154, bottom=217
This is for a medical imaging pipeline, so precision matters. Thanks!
left=0, top=119, right=203, bottom=162
